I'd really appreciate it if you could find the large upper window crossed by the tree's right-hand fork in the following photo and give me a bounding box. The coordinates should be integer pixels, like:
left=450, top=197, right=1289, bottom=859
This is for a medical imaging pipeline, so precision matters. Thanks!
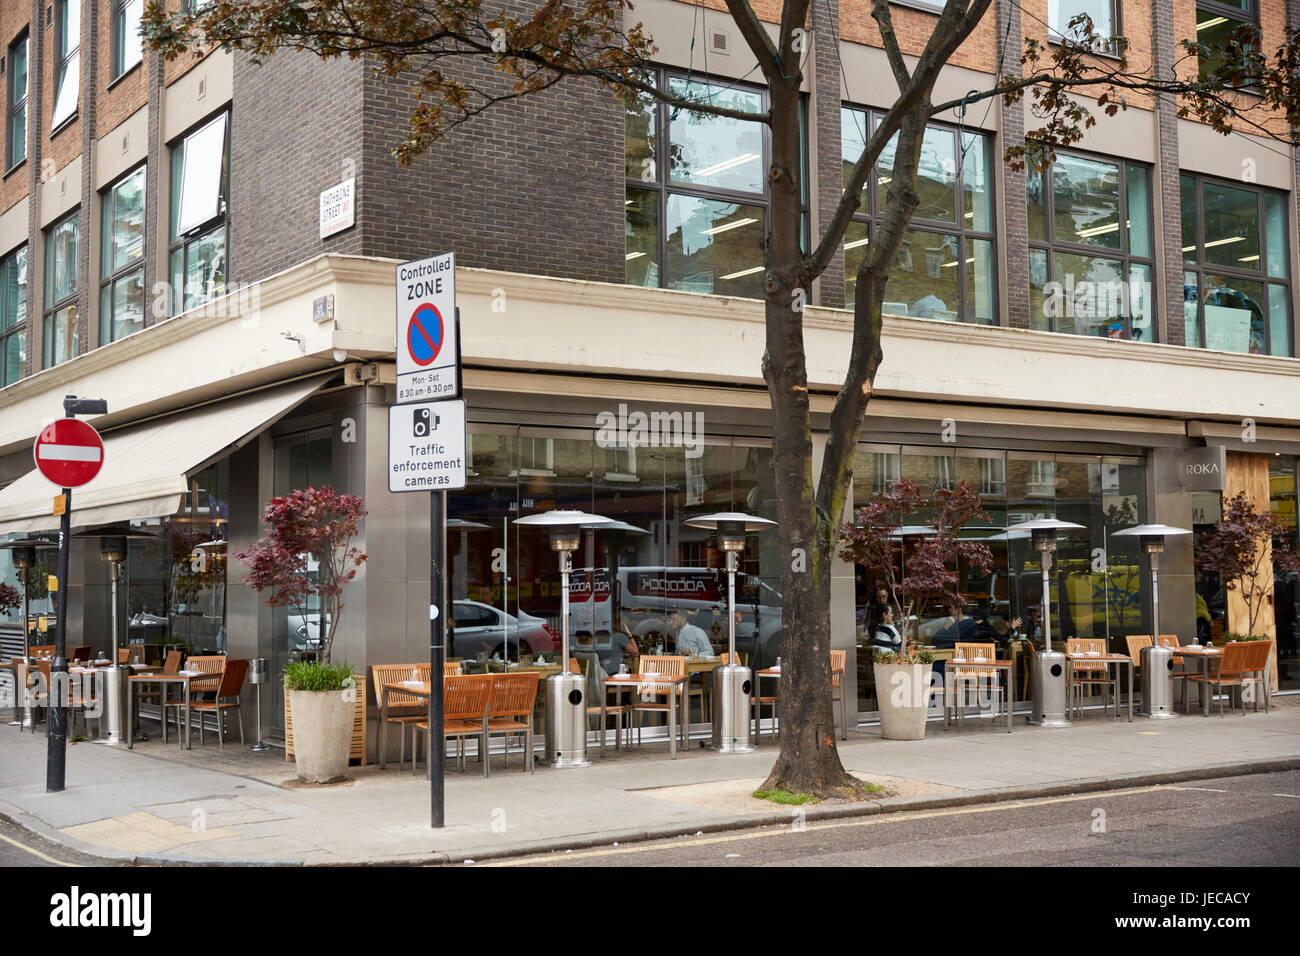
left=840, top=107, right=997, bottom=325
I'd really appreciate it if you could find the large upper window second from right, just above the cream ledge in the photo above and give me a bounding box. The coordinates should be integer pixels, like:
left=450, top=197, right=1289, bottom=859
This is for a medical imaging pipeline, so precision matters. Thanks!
left=1026, top=152, right=1156, bottom=342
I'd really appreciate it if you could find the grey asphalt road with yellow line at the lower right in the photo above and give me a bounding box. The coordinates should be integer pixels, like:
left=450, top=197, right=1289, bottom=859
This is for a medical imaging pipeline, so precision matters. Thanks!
left=481, top=771, right=1300, bottom=866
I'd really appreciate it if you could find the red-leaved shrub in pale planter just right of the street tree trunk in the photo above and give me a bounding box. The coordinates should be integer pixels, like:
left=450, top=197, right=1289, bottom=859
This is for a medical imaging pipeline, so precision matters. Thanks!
left=840, top=480, right=993, bottom=740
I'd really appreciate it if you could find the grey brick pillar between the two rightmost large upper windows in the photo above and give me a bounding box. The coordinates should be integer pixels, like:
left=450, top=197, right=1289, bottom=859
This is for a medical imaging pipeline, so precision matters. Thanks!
left=1151, top=0, right=1187, bottom=345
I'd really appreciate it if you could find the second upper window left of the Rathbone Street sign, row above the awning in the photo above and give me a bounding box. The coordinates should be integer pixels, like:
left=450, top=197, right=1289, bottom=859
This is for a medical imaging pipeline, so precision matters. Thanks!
left=99, top=166, right=144, bottom=343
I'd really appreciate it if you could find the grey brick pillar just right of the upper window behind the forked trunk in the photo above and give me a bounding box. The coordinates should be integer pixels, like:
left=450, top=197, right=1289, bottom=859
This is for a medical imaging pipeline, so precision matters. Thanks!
left=997, top=0, right=1030, bottom=329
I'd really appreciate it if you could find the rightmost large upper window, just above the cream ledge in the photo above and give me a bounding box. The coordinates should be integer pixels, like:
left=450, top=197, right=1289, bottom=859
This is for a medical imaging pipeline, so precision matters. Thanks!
left=1182, top=173, right=1291, bottom=355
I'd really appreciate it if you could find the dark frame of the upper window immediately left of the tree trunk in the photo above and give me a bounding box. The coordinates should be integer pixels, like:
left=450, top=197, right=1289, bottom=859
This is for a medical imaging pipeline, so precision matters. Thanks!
left=624, top=66, right=810, bottom=295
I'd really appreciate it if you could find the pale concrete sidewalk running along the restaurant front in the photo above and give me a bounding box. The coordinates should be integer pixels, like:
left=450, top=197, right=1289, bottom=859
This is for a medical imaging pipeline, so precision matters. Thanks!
left=0, top=701, right=1300, bottom=864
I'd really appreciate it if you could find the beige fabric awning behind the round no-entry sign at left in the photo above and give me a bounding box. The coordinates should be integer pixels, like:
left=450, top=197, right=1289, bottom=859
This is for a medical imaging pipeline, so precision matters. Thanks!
left=0, top=377, right=325, bottom=533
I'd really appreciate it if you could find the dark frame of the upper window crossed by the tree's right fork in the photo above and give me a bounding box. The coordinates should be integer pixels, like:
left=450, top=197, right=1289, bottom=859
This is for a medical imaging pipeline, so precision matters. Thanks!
left=840, top=100, right=1000, bottom=326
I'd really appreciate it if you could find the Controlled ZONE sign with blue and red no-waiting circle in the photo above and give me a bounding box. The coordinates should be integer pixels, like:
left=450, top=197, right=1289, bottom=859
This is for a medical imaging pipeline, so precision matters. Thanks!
left=397, top=252, right=460, bottom=405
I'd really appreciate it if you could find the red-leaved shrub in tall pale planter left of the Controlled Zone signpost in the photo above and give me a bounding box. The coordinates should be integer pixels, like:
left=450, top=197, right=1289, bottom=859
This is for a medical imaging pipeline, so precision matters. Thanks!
left=235, top=486, right=367, bottom=783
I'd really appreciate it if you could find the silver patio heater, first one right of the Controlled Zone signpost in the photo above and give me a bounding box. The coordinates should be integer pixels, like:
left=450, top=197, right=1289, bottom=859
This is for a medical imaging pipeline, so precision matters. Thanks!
left=515, top=511, right=611, bottom=769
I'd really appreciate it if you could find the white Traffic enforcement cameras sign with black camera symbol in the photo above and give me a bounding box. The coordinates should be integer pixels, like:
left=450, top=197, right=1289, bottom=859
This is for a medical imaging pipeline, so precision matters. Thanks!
left=389, top=399, right=465, bottom=492
